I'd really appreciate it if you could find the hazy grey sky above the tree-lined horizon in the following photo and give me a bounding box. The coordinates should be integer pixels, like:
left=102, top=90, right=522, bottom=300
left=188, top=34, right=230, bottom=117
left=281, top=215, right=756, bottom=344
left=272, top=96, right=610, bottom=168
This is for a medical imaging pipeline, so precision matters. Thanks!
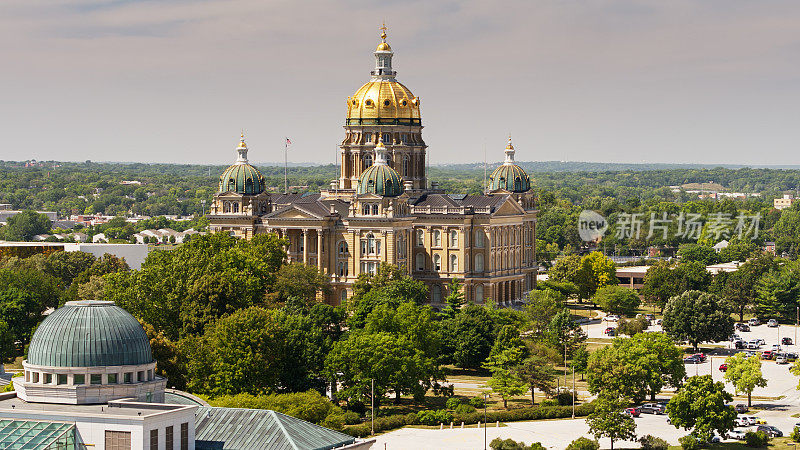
left=0, top=0, right=800, bottom=165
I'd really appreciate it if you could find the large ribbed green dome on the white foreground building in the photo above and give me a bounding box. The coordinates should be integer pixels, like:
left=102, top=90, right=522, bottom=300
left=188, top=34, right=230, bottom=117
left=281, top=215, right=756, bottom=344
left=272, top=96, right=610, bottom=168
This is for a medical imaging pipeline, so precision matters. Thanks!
left=28, top=301, right=153, bottom=367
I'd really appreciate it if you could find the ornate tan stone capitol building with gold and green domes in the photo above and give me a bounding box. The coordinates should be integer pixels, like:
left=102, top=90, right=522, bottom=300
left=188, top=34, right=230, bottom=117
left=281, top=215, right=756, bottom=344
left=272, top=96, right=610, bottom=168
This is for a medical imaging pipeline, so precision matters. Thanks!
left=208, top=27, right=537, bottom=306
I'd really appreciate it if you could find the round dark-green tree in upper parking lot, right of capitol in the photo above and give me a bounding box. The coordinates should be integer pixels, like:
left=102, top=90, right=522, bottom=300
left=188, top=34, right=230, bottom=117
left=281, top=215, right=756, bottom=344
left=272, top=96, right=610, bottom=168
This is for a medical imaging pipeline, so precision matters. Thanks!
left=662, top=291, right=733, bottom=351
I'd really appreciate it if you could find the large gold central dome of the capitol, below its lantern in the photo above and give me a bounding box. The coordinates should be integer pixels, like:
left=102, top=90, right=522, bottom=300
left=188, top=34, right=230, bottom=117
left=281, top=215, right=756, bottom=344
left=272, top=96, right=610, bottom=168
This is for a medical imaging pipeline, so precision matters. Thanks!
left=347, top=80, right=420, bottom=125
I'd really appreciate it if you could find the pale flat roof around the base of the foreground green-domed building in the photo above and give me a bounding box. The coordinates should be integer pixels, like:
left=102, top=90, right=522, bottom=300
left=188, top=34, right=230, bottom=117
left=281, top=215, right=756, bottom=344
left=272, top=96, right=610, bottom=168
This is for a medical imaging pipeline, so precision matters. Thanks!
left=0, top=392, right=196, bottom=418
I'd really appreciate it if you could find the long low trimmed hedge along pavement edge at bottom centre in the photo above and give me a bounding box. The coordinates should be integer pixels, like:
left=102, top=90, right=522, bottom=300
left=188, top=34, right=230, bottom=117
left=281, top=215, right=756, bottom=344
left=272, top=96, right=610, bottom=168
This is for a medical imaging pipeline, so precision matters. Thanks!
left=344, top=403, right=594, bottom=437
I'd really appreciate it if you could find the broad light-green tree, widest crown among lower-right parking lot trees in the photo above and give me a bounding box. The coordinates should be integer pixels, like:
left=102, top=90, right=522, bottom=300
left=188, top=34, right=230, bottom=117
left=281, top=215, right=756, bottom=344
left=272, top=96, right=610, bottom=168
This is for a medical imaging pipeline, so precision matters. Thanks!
left=587, top=333, right=686, bottom=402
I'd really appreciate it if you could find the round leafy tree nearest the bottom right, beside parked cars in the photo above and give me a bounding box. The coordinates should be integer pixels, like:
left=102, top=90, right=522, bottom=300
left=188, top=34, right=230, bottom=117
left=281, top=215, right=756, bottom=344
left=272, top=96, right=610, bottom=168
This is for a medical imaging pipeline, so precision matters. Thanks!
left=667, top=375, right=736, bottom=442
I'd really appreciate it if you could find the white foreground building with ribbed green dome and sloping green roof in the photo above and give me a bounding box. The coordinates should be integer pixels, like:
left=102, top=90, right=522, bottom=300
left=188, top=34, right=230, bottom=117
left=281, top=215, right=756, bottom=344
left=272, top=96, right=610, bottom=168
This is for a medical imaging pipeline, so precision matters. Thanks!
left=0, top=301, right=362, bottom=450
